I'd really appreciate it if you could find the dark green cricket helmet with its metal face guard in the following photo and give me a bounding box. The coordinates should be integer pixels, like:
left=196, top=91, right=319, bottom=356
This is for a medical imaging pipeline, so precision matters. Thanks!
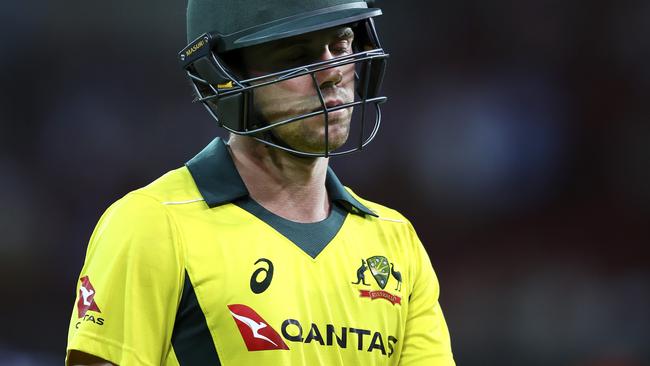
left=178, top=0, right=388, bottom=157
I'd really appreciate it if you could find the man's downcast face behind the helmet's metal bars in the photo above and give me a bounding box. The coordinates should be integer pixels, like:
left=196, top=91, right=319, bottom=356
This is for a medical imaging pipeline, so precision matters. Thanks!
left=242, top=27, right=355, bottom=153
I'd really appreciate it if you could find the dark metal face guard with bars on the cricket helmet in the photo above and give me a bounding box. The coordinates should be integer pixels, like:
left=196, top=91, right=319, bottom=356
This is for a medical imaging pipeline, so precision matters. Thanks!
left=181, top=20, right=388, bottom=157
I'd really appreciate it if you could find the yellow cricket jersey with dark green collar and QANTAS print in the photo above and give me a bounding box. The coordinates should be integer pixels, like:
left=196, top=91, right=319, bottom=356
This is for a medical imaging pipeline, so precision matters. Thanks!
left=67, top=138, right=454, bottom=366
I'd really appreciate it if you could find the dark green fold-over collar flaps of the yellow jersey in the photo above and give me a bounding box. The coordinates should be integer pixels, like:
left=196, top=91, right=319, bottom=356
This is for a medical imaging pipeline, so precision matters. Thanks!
left=185, top=137, right=377, bottom=216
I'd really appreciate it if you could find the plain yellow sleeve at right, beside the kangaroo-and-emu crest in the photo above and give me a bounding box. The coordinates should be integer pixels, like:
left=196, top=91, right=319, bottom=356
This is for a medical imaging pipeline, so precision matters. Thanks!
left=400, top=223, right=455, bottom=366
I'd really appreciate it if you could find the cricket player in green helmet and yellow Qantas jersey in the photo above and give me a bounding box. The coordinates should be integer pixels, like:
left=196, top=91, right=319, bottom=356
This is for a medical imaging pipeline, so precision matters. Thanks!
left=66, top=0, right=454, bottom=366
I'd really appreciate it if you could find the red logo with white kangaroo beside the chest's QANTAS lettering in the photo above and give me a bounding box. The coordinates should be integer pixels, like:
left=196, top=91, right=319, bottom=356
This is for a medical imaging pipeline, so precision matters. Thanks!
left=228, top=304, right=289, bottom=351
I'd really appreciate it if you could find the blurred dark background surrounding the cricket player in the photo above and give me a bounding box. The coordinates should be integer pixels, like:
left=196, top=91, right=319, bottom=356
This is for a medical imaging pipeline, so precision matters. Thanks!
left=0, top=0, right=650, bottom=366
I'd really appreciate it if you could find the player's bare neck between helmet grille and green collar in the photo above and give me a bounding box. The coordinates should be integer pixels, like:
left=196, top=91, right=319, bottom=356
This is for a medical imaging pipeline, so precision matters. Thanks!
left=228, top=135, right=330, bottom=223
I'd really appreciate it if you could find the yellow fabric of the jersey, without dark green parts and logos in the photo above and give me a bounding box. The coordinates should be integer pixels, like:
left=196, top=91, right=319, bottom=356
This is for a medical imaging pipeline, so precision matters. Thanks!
left=68, top=167, right=454, bottom=366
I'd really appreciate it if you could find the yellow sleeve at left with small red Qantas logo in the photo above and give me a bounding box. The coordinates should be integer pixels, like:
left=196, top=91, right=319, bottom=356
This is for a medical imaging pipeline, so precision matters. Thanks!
left=66, top=193, right=183, bottom=366
